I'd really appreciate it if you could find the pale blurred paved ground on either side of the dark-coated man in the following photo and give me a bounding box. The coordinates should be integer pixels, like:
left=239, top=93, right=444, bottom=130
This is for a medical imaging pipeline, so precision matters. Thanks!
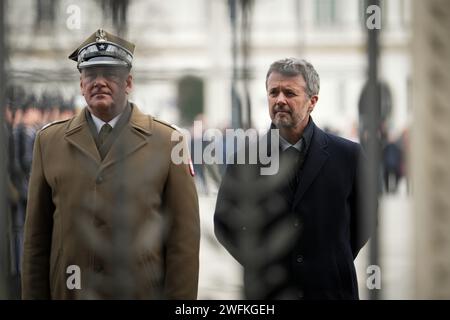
left=195, top=179, right=414, bottom=299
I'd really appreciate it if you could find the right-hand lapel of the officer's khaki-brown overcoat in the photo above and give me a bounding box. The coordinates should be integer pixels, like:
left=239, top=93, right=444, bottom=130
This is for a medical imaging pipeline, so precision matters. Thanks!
left=101, top=104, right=153, bottom=170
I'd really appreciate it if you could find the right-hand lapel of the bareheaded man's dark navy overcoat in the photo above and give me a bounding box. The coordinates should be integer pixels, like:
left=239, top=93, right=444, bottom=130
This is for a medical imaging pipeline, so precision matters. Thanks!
left=293, top=125, right=329, bottom=207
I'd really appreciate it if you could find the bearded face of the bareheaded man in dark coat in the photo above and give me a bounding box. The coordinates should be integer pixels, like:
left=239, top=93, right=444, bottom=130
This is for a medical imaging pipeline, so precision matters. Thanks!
left=267, top=72, right=318, bottom=129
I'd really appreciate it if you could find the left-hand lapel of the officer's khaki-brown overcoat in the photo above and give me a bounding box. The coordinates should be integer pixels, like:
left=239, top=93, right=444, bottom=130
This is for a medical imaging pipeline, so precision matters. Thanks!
left=65, top=110, right=101, bottom=164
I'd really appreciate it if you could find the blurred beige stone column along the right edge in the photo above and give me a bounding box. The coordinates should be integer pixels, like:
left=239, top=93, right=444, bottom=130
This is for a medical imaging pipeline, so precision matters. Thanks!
left=410, top=0, right=450, bottom=299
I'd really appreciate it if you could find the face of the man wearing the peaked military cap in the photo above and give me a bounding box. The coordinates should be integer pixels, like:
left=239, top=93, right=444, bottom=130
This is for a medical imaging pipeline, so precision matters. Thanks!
left=80, top=67, right=132, bottom=113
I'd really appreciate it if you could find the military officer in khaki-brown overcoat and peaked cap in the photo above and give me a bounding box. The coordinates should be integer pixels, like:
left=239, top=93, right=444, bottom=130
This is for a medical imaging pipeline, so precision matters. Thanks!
left=22, top=29, right=200, bottom=299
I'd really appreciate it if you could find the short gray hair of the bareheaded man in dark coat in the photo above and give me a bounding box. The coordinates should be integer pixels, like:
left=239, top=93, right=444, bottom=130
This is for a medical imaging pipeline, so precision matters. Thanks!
left=266, top=58, right=320, bottom=97
